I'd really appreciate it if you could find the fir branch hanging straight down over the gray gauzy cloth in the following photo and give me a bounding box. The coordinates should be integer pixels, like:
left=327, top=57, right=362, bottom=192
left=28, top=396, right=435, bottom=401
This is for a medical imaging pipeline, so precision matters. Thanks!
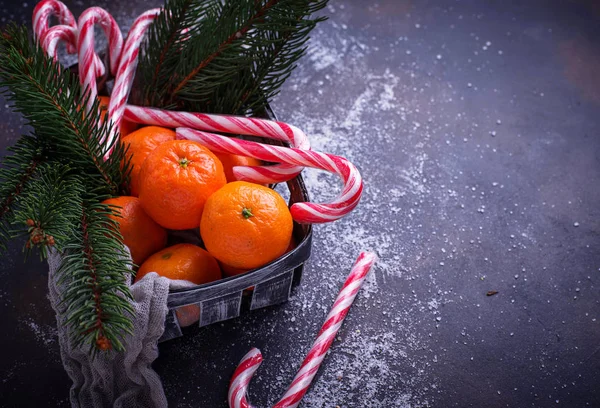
left=58, top=204, right=134, bottom=352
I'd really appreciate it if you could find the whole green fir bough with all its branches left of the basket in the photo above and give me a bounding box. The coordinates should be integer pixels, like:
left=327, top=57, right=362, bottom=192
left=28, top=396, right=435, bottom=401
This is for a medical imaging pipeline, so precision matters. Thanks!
left=0, top=25, right=133, bottom=350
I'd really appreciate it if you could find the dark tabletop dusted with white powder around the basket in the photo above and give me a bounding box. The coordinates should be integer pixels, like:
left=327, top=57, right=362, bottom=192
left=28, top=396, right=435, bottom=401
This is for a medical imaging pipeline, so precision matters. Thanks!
left=0, top=0, right=600, bottom=407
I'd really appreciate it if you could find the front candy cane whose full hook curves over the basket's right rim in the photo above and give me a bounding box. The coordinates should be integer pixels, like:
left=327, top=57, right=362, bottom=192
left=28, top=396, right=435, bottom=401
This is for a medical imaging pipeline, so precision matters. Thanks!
left=176, top=128, right=363, bottom=223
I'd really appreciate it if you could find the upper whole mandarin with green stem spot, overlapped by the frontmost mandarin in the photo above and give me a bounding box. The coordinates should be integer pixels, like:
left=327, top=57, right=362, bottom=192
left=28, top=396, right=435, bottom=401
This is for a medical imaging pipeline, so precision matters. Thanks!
left=139, top=140, right=227, bottom=230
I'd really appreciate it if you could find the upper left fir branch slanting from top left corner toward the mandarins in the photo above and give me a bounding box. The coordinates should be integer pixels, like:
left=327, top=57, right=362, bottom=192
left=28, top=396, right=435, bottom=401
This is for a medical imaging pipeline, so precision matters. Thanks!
left=0, top=25, right=128, bottom=195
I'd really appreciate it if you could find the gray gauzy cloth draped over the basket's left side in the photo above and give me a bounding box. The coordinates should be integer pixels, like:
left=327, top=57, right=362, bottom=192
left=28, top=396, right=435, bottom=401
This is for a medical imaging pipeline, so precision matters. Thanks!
left=48, top=252, right=170, bottom=408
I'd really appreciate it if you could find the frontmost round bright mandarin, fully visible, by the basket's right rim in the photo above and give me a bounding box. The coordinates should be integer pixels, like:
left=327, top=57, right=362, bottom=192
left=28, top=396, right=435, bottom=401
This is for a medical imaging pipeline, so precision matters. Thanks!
left=200, top=181, right=293, bottom=269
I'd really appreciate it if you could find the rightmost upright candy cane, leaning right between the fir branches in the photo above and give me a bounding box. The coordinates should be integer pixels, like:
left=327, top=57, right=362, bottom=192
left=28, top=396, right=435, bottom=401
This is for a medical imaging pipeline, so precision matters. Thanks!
left=104, top=8, right=161, bottom=160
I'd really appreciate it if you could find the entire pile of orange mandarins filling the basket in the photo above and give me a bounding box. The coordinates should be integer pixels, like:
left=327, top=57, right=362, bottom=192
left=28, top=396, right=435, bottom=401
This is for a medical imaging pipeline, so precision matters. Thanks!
left=104, top=99, right=293, bottom=298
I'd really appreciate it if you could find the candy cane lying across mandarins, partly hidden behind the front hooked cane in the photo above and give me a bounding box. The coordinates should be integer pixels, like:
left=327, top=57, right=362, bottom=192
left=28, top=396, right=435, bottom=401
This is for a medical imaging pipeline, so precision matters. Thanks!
left=124, top=105, right=310, bottom=184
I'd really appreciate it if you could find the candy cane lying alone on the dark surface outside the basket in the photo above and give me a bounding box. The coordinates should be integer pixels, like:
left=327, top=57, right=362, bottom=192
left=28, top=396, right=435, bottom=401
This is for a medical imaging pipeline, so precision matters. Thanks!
left=227, top=252, right=376, bottom=408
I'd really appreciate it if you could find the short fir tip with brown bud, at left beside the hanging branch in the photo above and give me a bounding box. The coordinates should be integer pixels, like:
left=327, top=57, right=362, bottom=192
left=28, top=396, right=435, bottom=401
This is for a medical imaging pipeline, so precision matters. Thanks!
left=11, top=164, right=84, bottom=258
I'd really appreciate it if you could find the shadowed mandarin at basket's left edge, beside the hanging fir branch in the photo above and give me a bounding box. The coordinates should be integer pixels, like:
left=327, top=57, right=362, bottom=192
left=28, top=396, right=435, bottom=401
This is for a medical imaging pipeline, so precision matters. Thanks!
left=102, top=196, right=167, bottom=265
